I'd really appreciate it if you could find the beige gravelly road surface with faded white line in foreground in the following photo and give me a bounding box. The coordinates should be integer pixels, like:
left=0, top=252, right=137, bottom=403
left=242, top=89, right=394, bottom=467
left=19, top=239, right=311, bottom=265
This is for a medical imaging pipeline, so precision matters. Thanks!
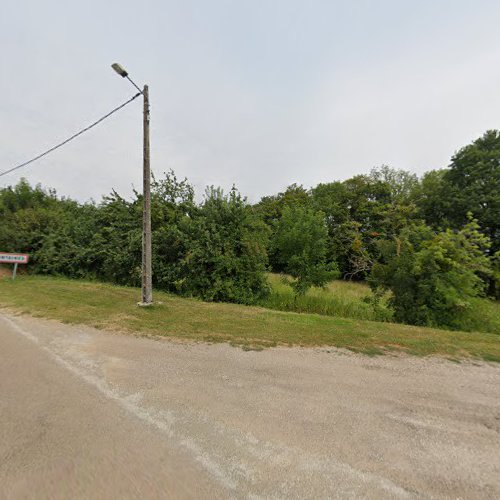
left=0, top=313, right=500, bottom=499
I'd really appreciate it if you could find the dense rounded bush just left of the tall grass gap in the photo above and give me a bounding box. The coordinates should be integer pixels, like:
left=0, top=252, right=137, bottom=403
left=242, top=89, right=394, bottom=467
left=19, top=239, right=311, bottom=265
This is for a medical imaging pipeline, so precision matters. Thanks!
left=179, top=187, right=267, bottom=304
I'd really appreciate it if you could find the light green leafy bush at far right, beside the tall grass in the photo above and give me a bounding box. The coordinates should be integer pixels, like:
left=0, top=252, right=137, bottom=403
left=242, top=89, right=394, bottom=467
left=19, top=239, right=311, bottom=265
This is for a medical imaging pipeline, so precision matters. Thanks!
left=371, top=220, right=491, bottom=328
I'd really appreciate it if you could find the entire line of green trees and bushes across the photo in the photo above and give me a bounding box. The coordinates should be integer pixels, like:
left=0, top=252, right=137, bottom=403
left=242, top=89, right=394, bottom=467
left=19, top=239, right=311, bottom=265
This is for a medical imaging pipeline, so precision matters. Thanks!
left=0, top=130, right=500, bottom=328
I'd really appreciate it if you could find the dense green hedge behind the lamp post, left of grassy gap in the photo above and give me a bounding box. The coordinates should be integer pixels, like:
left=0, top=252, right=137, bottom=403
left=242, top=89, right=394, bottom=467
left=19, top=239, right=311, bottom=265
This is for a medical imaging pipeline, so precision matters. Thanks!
left=0, top=172, right=268, bottom=303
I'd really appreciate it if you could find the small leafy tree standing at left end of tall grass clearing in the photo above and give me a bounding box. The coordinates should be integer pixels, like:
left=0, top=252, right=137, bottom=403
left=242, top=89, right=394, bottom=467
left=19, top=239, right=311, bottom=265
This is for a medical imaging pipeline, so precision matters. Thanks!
left=273, top=205, right=338, bottom=295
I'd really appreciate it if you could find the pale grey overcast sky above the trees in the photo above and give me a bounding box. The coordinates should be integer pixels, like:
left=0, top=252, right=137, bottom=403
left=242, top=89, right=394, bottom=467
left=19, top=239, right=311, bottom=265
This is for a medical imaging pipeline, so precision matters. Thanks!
left=0, top=0, right=500, bottom=201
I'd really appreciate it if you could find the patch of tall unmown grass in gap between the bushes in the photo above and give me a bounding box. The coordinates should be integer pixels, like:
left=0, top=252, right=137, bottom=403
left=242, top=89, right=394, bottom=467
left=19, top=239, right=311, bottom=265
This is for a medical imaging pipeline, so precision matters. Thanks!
left=260, top=274, right=391, bottom=321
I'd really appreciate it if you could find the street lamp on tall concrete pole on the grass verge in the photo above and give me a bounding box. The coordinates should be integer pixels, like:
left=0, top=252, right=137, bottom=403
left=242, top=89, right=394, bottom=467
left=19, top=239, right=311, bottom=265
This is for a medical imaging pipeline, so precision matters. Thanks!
left=111, top=63, right=153, bottom=306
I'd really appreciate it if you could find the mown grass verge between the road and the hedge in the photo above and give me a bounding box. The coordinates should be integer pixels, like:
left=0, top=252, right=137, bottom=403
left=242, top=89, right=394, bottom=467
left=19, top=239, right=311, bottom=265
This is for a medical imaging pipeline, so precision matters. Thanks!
left=0, top=276, right=500, bottom=362
